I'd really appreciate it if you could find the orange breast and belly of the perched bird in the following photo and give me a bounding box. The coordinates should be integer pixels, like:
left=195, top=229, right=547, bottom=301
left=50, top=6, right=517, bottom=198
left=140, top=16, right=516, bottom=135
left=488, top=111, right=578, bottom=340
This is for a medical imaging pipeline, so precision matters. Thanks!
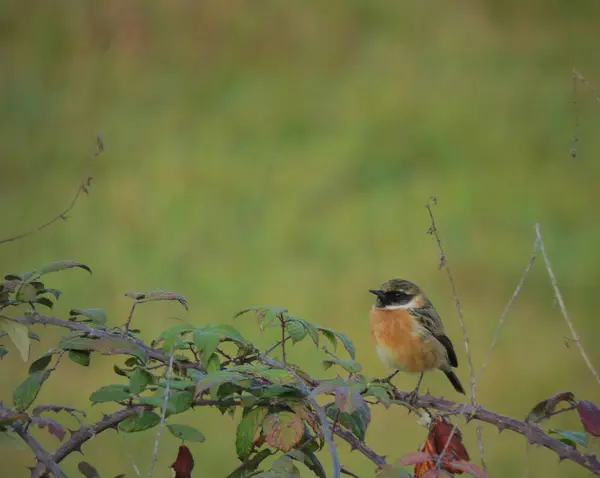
left=371, top=309, right=447, bottom=372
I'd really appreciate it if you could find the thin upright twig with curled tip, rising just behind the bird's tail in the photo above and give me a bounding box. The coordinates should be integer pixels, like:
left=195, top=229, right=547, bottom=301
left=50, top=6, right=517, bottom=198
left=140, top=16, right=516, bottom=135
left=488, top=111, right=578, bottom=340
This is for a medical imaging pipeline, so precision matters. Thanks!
left=425, top=198, right=487, bottom=470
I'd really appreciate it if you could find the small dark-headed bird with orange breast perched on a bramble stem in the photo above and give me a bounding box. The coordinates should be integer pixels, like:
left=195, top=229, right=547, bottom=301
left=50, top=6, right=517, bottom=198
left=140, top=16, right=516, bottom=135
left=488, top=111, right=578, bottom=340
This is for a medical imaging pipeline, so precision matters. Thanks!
left=369, top=279, right=465, bottom=398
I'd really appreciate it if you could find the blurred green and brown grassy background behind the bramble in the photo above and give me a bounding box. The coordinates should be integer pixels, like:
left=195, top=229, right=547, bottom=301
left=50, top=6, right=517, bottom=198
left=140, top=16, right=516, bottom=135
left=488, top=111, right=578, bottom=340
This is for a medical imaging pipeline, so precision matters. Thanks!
left=0, top=0, right=600, bottom=477
